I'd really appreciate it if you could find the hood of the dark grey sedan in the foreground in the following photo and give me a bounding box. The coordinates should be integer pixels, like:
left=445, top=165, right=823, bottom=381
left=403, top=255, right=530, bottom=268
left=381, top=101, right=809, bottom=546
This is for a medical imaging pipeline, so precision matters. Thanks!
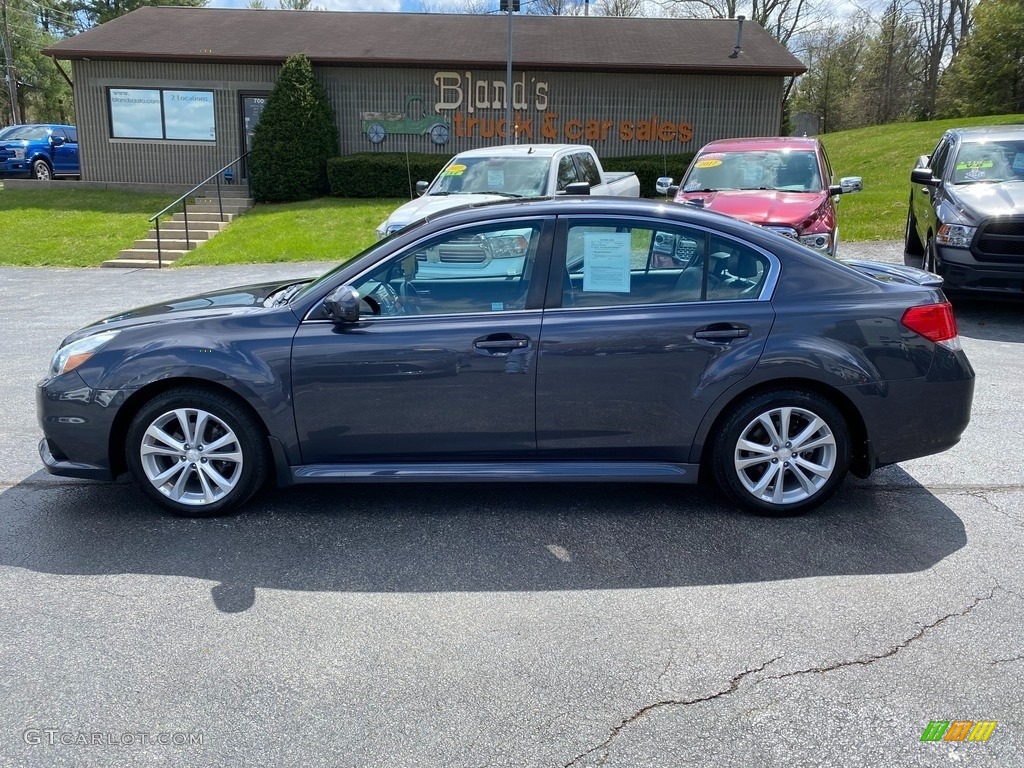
left=63, top=279, right=309, bottom=344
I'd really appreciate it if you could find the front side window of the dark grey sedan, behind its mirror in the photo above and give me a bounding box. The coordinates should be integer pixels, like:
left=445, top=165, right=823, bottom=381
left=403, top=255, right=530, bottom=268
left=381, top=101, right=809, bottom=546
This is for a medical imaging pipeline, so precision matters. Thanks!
left=352, top=221, right=543, bottom=316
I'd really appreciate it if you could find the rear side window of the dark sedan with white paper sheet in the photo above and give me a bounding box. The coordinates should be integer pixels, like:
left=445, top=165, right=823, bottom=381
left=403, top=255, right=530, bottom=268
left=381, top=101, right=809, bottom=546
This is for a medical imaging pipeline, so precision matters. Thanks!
left=562, top=222, right=769, bottom=307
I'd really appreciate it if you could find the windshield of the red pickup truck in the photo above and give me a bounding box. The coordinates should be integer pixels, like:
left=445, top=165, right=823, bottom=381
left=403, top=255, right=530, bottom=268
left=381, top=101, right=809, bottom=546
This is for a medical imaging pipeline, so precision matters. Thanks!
left=681, top=150, right=823, bottom=193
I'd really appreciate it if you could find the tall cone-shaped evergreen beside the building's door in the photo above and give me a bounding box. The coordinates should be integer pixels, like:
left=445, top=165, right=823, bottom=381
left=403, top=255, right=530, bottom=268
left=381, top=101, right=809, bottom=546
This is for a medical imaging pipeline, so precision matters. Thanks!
left=249, top=53, right=339, bottom=203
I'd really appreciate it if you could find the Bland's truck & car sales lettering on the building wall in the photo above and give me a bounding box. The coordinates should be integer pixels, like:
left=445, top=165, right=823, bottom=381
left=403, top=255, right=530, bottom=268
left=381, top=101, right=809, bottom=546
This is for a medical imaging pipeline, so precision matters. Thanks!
left=433, top=71, right=693, bottom=144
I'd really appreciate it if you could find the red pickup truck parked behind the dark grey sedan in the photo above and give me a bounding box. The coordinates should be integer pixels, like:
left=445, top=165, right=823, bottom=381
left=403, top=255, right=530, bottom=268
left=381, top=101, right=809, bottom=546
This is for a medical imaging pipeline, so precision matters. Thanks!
left=656, top=137, right=863, bottom=256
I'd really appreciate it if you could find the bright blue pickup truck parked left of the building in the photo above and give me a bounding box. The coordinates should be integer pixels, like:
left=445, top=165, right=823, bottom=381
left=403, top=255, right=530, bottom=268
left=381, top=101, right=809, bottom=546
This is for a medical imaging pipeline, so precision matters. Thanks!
left=0, top=124, right=82, bottom=181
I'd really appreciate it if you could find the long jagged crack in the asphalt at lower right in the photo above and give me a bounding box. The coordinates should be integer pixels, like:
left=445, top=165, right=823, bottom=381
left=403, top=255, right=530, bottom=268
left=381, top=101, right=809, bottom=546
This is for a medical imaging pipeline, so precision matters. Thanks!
left=562, top=587, right=995, bottom=768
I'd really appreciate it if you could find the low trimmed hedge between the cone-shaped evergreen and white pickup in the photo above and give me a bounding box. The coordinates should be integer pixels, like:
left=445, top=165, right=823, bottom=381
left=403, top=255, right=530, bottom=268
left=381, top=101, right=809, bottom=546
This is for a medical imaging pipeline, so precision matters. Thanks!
left=327, top=152, right=450, bottom=198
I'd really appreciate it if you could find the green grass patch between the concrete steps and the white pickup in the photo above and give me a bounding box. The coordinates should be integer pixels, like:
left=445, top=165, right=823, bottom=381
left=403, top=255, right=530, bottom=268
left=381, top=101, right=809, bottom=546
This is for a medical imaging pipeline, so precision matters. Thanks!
left=176, top=198, right=406, bottom=265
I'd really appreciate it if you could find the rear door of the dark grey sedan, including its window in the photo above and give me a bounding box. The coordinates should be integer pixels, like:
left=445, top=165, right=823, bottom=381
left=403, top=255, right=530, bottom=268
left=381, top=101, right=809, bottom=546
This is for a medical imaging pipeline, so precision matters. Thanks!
left=537, top=217, right=778, bottom=462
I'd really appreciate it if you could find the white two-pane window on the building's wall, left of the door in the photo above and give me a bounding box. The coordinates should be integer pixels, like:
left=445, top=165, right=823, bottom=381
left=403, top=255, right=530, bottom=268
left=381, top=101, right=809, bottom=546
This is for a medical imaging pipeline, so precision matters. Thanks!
left=108, top=88, right=217, bottom=141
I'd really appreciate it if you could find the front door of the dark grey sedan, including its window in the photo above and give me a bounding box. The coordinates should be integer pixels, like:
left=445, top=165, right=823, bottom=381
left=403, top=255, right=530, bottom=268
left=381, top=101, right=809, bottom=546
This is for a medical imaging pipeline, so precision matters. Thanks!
left=292, top=219, right=551, bottom=464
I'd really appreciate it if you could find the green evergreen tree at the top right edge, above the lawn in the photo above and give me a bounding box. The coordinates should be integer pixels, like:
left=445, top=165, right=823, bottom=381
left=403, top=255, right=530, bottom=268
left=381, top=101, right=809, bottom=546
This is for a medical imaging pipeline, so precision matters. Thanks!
left=938, top=0, right=1024, bottom=117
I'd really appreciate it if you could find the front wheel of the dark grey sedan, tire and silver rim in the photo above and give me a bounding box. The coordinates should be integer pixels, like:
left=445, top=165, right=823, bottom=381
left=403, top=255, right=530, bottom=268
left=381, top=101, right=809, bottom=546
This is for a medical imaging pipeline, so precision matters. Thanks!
left=126, top=387, right=268, bottom=517
